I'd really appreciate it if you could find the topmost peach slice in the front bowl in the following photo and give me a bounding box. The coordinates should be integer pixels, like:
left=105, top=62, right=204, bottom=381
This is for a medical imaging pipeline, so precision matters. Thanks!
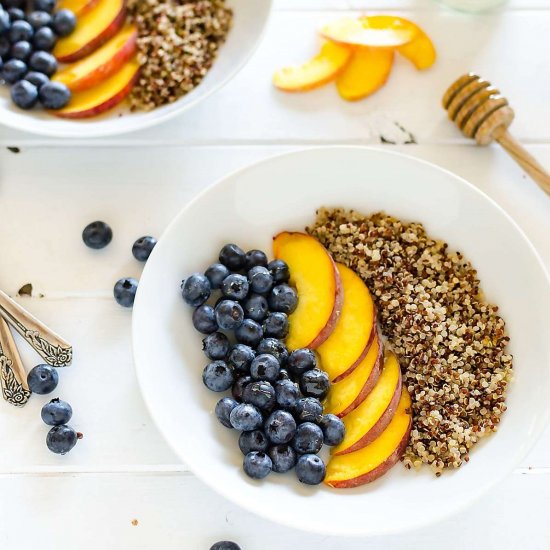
left=273, top=232, right=344, bottom=350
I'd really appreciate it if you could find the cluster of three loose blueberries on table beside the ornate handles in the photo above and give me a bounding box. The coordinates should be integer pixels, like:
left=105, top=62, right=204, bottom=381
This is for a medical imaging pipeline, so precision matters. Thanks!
left=27, top=365, right=82, bottom=455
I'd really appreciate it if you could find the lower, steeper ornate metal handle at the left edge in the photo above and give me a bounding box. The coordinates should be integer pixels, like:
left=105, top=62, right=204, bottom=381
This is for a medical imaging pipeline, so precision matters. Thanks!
left=0, top=317, right=31, bottom=407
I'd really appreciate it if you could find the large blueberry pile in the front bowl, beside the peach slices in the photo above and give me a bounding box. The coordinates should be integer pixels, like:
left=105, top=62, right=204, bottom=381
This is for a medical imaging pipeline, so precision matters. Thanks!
left=182, top=244, right=344, bottom=485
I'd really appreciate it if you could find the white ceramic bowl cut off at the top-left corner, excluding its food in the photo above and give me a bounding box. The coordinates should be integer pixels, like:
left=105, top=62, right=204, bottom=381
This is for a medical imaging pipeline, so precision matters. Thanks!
left=0, top=0, right=273, bottom=138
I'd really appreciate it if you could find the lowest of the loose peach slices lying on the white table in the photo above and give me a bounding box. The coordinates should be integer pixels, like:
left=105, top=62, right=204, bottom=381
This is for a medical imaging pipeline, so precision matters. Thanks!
left=336, top=48, right=393, bottom=101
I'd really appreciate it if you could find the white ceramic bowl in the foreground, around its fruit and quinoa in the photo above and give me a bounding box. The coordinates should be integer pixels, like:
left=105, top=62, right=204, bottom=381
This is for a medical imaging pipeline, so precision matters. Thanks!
left=133, top=147, right=550, bottom=535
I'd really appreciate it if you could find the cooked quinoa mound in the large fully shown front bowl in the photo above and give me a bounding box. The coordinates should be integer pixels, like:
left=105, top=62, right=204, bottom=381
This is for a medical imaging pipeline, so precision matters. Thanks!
left=308, top=209, right=512, bottom=475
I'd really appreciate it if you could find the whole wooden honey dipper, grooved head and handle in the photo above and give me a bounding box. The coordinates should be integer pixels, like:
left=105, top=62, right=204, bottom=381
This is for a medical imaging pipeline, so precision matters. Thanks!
left=442, top=73, right=550, bottom=195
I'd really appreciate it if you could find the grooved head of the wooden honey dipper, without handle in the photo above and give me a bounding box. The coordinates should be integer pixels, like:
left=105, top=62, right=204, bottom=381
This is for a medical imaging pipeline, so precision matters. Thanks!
left=442, top=73, right=514, bottom=145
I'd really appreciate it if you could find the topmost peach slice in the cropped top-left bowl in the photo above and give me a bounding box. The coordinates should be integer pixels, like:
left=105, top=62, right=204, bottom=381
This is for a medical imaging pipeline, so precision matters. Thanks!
left=53, top=0, right=126, bottom=63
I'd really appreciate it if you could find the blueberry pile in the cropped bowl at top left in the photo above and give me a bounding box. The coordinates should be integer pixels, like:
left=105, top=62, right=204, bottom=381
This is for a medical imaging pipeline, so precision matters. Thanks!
left=0, top=0, right=76, bottom=109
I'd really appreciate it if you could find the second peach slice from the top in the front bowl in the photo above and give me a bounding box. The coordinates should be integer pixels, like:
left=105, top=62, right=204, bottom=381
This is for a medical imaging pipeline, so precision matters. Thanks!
left=316, top=264, right=376, bottom=382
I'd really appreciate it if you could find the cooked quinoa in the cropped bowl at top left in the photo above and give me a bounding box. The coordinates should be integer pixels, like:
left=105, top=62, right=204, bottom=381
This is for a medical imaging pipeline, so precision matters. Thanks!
left=128, top=0, right=233, bottom=111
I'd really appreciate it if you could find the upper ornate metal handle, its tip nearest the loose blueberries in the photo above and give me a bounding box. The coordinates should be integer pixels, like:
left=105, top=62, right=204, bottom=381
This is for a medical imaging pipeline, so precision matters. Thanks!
left=0, top=290, right=73, bottom=367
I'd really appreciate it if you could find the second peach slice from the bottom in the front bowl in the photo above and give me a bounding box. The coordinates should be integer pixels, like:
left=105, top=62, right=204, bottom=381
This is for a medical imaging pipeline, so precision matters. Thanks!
left=333, top=353, right=401, bottom=455
